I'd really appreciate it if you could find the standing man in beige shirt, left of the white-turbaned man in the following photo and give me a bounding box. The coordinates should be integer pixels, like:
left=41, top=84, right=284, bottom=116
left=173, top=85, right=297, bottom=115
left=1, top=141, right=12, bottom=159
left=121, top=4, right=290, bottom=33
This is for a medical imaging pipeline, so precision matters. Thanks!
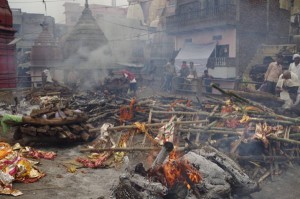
left=265, top=55, right=283, bottom=95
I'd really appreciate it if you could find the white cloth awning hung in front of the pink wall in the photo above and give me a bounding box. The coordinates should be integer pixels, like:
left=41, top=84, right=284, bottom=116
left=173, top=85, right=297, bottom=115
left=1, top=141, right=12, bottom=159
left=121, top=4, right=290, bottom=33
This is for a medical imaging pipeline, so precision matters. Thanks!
left=175, top=42, right=216, bottom=76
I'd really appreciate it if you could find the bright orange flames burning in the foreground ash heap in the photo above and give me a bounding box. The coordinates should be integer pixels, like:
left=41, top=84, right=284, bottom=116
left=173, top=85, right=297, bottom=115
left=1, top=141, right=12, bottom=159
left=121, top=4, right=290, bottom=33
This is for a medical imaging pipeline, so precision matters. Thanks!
left=163, top=150, right=202, bottom=189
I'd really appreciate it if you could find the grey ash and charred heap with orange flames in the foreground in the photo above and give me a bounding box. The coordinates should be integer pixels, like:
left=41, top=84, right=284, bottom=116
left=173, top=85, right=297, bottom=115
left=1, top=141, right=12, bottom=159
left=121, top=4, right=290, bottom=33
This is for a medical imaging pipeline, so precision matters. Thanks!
left=113, top=142, right=259, bottom=199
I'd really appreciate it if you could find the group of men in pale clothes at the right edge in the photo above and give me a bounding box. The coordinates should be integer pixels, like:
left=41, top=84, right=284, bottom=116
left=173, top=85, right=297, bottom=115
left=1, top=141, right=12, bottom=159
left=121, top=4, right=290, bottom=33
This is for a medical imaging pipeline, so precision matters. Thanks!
left=262, top=54, right=300, bottom=107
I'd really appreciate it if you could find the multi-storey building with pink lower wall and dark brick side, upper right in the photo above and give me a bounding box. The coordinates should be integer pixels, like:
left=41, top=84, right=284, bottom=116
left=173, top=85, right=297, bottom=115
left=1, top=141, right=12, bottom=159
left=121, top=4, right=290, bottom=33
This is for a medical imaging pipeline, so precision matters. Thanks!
left=166, top=0, right=290, bottom=78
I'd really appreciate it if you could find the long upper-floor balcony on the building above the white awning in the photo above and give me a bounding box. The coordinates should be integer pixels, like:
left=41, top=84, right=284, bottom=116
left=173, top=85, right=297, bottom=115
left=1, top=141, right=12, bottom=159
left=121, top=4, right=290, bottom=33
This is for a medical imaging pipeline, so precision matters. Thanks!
left=166, top=4, right=236, bottom=34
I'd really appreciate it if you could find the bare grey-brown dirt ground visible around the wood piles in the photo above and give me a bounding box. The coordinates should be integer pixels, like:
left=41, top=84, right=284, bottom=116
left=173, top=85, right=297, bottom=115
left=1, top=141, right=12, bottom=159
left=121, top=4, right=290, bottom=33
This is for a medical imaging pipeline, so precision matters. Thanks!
left=0, top=88, right=300, bottom=199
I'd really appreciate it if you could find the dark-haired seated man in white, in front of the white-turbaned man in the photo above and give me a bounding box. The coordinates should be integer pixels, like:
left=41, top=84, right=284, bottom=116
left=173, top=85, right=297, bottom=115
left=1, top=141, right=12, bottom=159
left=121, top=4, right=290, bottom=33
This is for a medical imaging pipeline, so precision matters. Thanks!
left=276, top=71, right=299, bottom=106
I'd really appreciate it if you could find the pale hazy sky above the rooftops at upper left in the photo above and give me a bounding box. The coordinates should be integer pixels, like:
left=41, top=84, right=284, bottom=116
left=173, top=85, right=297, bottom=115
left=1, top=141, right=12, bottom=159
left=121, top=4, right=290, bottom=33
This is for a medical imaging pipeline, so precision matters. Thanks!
left=8, top=0, right=128, bottom=23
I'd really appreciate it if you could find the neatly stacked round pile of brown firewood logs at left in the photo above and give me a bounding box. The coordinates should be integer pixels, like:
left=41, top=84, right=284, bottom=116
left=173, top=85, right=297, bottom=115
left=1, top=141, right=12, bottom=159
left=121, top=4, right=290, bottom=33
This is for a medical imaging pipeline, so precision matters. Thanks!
left=15, top=102, right=96, bottom=142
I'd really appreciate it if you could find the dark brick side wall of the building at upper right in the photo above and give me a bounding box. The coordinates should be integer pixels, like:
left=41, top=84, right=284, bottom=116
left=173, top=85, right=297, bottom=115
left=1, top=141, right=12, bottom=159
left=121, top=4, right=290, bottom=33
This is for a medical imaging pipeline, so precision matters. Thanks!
left=237, top=0, right=289, bottom=74
